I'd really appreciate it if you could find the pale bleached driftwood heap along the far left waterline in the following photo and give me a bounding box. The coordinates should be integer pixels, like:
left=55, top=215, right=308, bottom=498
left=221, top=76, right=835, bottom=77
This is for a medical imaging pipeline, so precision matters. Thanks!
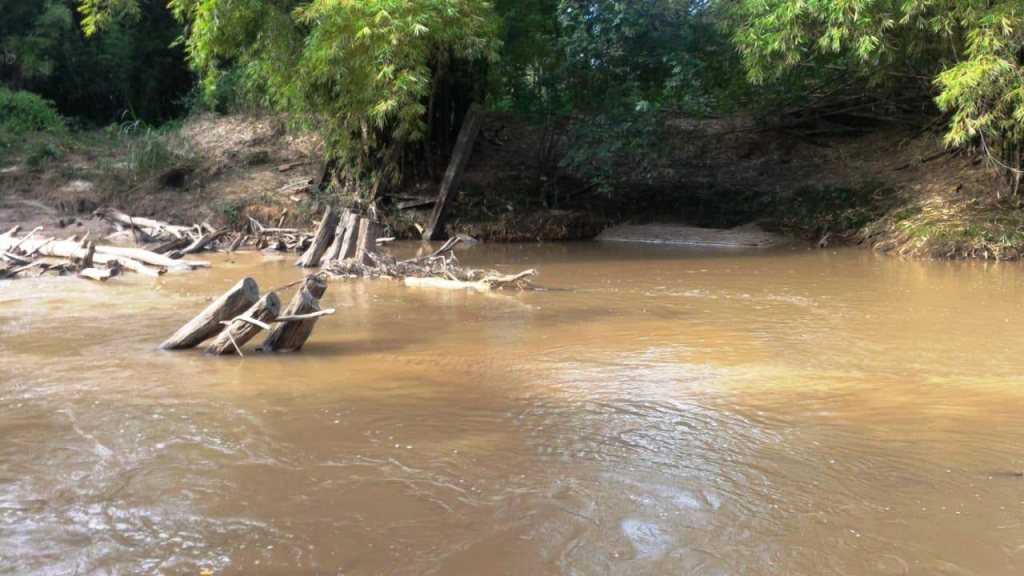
left=0, top=222, right=210, bottom=282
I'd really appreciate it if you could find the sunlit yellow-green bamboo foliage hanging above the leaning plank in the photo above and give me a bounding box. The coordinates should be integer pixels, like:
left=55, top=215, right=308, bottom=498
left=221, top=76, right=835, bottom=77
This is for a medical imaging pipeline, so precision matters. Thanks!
left=158, top=0, right=498, bottom=171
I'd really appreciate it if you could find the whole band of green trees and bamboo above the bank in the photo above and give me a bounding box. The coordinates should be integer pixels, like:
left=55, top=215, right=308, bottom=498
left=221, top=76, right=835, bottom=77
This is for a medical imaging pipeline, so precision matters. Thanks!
left=6, top=0, right=1024, bottom=253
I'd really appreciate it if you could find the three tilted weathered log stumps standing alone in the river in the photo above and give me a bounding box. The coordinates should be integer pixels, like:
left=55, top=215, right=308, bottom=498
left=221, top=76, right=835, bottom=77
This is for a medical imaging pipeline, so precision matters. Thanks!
left=160, top=275, right=335, bottom=356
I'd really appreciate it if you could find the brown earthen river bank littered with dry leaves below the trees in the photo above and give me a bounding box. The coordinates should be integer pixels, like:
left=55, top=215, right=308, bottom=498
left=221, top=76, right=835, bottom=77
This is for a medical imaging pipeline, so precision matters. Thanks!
left=0, top=109, right=1011, bottom=255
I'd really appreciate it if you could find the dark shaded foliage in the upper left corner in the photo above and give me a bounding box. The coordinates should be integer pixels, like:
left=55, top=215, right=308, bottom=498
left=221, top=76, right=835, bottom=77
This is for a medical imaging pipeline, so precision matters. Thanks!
left=0, top=0, right=194, bottom=124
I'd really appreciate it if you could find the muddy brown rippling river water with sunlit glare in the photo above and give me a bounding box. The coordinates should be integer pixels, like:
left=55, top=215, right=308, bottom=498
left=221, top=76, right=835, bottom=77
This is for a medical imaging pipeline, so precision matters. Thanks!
left=0, top=243, right=1024, bottom=576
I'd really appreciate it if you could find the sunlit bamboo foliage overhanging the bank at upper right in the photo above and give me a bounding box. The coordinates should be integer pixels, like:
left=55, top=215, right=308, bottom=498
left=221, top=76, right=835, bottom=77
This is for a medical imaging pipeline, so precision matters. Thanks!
left=719, top=0, right=1024, bottom=175
